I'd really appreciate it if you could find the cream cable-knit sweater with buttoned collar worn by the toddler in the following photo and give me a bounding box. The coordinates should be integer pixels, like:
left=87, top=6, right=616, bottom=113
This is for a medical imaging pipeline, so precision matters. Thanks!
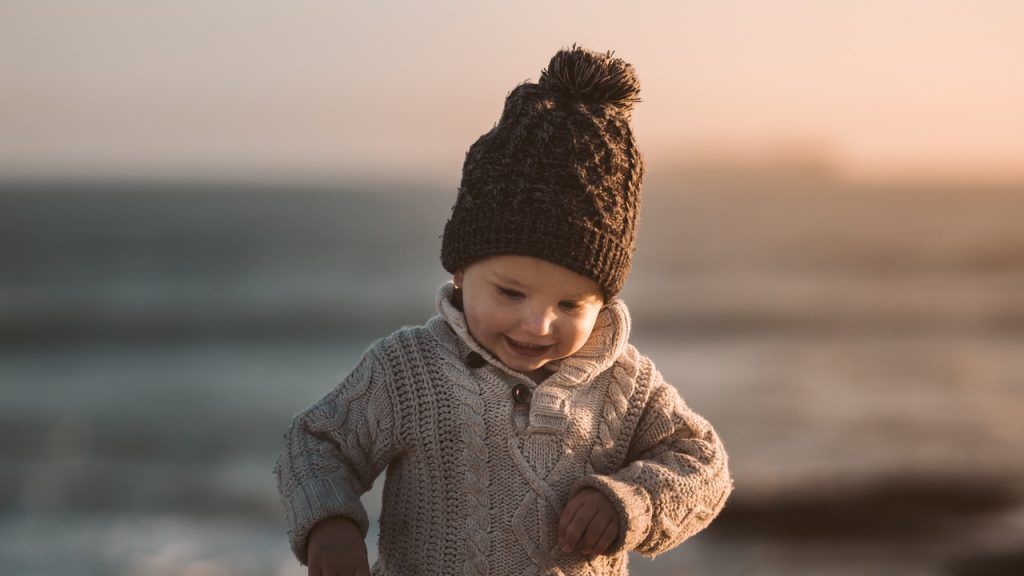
left=274, top=284, right=732, bottom=576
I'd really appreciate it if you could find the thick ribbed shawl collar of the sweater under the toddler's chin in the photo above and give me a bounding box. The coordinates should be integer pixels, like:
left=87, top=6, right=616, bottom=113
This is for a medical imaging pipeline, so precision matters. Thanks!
left=437, top=282, right=631, bottom=386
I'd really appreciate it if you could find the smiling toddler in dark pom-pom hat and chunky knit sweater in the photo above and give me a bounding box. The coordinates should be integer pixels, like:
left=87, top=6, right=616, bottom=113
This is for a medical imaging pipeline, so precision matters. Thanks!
left=274, top=46, right=732, bottom=576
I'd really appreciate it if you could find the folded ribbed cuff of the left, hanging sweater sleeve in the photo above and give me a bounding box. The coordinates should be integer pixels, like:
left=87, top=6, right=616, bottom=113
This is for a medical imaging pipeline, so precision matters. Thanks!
left=285, top=474, right=370, bottom=565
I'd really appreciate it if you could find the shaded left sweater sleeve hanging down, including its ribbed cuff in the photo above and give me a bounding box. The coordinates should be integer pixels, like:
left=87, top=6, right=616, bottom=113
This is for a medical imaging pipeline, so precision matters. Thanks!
left=273, top=342, right=397, bottom=565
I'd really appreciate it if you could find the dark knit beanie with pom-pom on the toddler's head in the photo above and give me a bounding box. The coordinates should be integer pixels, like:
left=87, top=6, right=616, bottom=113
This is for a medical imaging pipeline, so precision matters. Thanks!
left=441, top=45, right=644, bottom=298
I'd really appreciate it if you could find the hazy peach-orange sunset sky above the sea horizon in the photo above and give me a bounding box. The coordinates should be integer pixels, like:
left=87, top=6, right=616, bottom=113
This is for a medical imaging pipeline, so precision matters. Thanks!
left=0, top=0, right=1024, bottom=186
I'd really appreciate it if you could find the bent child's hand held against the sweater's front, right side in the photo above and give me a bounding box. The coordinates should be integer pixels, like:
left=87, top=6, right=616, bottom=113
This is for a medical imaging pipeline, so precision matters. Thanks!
left=558, top=488, right=618, bottom=556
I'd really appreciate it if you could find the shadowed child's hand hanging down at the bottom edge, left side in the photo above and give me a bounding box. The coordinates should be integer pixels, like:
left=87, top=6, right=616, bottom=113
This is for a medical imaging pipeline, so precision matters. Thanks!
left=307, top=517, right=370, bottom=576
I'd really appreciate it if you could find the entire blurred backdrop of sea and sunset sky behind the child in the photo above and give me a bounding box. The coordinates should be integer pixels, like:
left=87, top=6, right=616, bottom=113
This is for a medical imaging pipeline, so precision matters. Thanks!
left=0, top=0, right=1024, bottom=576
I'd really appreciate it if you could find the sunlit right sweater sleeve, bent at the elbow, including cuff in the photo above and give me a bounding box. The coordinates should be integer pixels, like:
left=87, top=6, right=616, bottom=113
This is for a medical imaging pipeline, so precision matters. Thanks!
left=573, top=362, right=732, bottom=558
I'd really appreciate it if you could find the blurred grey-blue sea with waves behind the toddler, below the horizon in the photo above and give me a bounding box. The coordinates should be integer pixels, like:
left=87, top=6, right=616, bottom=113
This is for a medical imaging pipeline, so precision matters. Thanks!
left=0, top=175, right=1024, bottom=576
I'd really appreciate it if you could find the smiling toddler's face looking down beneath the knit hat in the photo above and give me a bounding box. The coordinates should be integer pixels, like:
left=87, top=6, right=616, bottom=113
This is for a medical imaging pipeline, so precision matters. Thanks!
left=455, top=256, right=604, bottom=375
